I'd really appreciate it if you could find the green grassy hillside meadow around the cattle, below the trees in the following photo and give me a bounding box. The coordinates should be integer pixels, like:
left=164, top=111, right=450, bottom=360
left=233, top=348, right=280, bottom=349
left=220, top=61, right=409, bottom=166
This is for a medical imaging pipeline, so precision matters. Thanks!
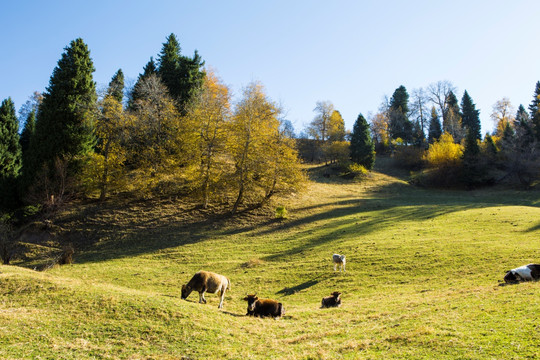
left=0, top=161, right=540, bottom=359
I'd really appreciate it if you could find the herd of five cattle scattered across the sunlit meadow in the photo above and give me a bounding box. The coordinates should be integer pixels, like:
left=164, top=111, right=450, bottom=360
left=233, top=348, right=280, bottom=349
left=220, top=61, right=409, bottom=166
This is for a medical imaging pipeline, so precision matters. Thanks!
left=182, top=254, right=540, bottom=318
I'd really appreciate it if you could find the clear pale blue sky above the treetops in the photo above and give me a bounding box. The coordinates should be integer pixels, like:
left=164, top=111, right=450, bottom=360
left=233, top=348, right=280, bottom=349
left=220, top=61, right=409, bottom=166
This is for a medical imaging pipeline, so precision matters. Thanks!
left=0, top=0, right=540, bottom=133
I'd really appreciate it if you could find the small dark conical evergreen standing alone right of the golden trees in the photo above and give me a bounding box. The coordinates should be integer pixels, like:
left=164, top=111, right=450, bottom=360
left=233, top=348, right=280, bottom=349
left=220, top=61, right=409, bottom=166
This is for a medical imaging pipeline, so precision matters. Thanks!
left=350, top=114, right=375, bottom=170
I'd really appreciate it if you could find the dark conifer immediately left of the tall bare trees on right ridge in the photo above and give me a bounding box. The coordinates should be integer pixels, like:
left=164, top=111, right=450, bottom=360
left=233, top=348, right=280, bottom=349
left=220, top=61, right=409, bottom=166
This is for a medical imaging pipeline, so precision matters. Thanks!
left=389, top=85, right=413, bottom=143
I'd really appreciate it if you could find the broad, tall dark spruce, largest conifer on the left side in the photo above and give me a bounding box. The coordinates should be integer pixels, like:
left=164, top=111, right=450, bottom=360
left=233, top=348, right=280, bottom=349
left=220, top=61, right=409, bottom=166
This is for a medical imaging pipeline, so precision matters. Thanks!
left=25, top=38, right=97, bottom=188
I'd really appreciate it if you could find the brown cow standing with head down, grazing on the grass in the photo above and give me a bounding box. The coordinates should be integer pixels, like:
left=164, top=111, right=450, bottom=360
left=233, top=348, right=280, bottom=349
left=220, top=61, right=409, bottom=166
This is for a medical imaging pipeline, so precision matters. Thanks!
left=182, top=270, right=231, bottom=309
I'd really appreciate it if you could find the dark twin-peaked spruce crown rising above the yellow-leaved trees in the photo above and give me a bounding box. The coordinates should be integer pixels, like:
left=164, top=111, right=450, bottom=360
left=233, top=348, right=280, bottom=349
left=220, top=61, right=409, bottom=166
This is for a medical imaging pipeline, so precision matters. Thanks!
left=157, top=34, right=204, bottom=113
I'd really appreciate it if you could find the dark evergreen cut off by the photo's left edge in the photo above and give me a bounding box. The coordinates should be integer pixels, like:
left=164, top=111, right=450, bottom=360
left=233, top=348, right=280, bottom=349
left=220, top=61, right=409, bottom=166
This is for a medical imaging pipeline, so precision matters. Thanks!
left=0, top=98, right=22, bottom=208
